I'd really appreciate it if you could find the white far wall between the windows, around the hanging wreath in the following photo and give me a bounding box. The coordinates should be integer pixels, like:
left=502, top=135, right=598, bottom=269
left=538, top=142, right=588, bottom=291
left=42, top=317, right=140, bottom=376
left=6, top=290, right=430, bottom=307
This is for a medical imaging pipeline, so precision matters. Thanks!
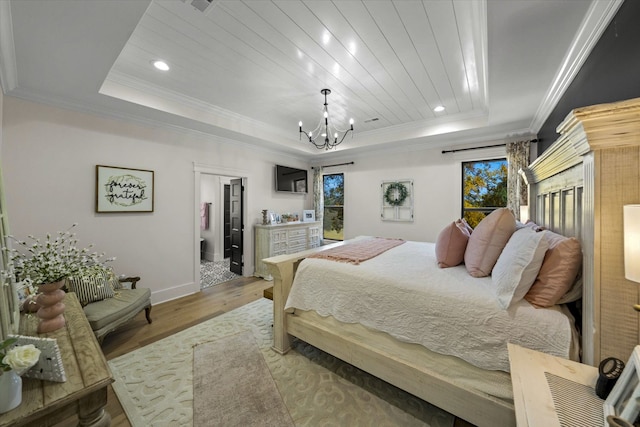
left=336, top=147, right=505, bottom=242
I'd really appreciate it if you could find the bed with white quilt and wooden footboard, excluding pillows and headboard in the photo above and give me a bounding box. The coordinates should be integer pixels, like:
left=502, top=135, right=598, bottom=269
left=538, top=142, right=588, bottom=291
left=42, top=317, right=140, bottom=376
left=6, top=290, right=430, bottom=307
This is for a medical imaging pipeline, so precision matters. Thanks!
left=265, top=229, right=579, bottom=426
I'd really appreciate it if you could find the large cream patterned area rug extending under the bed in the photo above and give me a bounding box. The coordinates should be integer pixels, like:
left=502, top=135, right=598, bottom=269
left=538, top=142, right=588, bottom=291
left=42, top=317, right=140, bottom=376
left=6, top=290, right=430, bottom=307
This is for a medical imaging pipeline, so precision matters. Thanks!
left=109, top=299, right=454, bottom=427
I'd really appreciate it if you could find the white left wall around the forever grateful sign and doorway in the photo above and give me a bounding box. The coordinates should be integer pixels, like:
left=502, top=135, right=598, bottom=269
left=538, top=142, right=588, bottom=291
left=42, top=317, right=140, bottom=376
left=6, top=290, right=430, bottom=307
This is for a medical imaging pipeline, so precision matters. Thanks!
left=1, top=96, right=311, bottom=303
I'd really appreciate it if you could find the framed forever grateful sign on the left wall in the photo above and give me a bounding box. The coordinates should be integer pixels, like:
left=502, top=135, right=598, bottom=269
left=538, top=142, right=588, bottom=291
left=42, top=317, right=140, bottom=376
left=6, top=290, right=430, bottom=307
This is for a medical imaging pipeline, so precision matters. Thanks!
left=96, top=165, right=154, bottom=212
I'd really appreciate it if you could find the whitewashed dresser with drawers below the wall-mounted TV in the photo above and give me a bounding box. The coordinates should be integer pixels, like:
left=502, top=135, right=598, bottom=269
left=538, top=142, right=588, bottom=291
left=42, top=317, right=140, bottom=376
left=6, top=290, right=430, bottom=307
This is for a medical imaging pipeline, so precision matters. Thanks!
left=254, top=221, right=322, bottom=280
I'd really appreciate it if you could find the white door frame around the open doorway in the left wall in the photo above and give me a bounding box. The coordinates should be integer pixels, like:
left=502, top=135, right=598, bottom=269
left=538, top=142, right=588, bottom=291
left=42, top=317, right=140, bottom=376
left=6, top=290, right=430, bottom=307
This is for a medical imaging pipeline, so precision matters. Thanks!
left=192, top=162, right=254, bottom=291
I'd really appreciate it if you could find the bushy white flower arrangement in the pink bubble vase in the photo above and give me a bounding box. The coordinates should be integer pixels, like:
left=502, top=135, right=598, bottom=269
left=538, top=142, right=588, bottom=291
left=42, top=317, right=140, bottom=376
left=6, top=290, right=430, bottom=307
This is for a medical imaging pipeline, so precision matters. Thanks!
left=2, top=224, right=115, bottom=287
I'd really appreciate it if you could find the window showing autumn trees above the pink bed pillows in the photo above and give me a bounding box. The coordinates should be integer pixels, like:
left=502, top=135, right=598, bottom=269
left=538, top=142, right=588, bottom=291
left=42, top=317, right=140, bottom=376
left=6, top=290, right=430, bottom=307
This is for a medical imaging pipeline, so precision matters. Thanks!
left=462, top=159, right=507, bottom=227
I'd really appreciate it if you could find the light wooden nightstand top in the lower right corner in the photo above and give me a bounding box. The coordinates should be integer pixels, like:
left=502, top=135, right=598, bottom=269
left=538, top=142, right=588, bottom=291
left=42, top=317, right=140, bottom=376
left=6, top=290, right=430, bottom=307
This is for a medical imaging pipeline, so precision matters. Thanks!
left=508, top=344, right=604, bottom=427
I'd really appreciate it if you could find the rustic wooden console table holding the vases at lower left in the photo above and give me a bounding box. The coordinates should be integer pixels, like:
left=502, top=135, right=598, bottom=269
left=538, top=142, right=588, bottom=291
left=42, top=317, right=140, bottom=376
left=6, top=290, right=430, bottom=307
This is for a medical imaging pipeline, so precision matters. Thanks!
left=0, top=293, right=113, bottom=427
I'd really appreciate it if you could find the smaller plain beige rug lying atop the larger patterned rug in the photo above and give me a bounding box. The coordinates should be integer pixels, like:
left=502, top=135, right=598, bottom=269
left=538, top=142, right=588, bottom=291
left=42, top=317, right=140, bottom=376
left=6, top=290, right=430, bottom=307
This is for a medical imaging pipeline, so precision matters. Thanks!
left=193, top=331, right=294, bottom=427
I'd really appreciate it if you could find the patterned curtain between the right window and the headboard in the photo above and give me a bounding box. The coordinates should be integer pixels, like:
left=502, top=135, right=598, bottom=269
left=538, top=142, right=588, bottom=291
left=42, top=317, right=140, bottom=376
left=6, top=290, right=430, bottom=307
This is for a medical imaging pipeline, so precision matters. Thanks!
left=507, top=141, right=531, bottom=219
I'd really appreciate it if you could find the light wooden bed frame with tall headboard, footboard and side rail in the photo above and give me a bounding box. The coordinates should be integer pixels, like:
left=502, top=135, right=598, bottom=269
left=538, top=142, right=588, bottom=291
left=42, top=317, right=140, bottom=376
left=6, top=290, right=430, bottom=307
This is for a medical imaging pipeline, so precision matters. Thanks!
left=264, top=99, right=640, bottom=426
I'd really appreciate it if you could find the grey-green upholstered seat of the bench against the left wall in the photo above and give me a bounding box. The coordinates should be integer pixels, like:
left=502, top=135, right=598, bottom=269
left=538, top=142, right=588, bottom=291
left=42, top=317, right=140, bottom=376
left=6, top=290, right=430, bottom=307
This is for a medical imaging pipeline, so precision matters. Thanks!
left=83, top=288, right=151, bottom=331
